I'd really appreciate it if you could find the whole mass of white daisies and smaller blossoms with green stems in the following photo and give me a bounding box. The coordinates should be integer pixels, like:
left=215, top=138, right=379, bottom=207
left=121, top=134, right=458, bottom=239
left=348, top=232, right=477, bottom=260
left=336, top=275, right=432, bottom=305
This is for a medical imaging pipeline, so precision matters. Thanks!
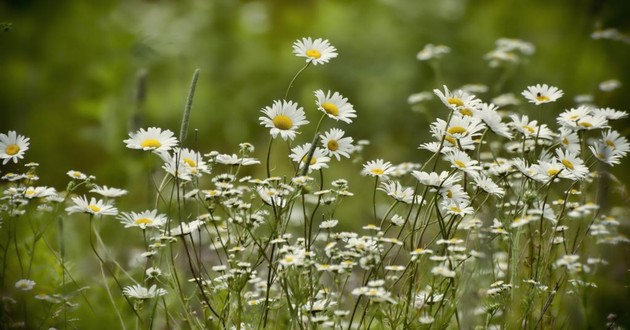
left=0, top=38, right=630, bottom=329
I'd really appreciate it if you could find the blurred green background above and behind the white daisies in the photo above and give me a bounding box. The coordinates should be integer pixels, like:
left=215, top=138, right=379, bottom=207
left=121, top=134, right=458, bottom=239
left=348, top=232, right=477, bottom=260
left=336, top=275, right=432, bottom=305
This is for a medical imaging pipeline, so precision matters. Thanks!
left=0, top=0, right=630, bottom=324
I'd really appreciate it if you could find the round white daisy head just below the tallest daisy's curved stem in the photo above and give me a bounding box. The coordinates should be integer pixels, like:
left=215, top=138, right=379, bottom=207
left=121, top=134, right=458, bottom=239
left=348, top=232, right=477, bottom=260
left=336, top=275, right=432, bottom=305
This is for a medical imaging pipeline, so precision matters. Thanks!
left=258, top=100, right=308, bottom=141
